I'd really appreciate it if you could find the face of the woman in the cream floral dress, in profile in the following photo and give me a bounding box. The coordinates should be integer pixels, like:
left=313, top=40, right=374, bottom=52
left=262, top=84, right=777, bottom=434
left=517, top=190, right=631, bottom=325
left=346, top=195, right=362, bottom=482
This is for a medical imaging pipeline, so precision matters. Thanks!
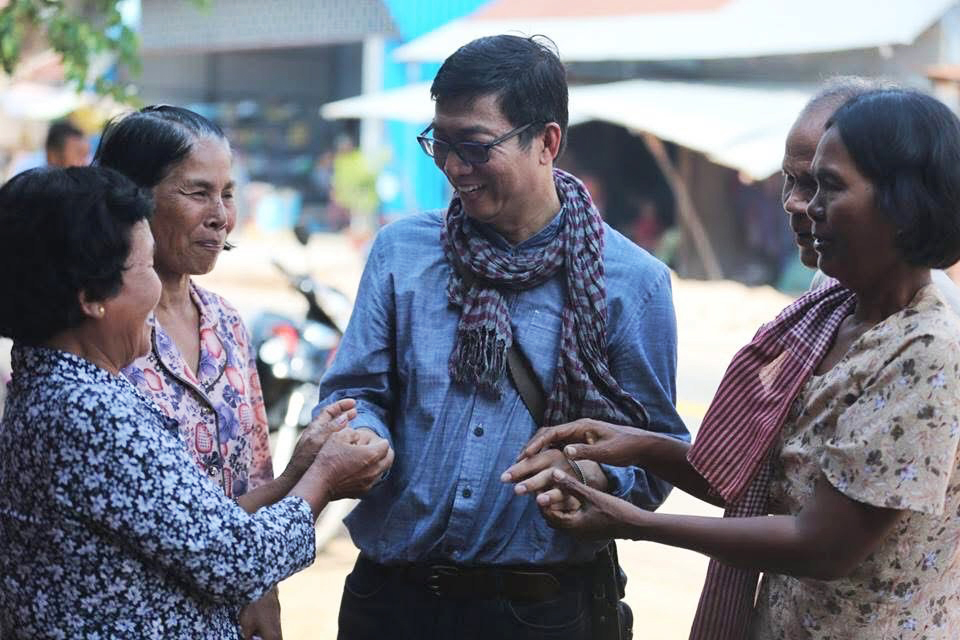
left=807, top=127, right=903, bottom=290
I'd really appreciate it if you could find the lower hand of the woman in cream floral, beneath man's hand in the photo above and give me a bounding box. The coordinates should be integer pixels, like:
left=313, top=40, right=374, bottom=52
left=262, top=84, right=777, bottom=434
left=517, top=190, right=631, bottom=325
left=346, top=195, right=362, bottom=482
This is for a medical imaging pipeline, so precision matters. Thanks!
left=537, top=471, right=644, bottom=538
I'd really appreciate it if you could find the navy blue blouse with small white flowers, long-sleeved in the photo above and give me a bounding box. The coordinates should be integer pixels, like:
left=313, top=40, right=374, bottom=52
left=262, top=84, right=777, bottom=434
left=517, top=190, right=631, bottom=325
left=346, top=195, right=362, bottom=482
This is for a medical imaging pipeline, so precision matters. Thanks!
left=0, top=346, right=314, bottom=640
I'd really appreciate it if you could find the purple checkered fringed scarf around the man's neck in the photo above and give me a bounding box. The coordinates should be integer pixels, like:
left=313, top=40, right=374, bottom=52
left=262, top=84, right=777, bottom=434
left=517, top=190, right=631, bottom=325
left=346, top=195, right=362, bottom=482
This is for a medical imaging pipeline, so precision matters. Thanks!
left=440, top=169, right=647, bottom=427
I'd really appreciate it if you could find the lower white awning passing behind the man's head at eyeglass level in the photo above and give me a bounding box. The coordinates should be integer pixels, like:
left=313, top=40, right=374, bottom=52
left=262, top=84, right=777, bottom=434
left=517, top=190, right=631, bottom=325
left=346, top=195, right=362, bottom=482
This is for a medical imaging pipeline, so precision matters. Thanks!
left=320, top=80, right=810, bottom=180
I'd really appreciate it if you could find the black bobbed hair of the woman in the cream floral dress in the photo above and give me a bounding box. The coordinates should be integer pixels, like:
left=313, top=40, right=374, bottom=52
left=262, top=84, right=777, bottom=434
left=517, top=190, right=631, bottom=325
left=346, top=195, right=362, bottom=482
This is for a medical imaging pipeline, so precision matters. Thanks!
left=827, top=89, right=960, bottom=268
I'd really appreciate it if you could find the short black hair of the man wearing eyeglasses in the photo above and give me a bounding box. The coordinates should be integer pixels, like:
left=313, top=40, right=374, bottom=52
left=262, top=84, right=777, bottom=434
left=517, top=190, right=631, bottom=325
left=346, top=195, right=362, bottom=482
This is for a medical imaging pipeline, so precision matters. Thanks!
left=430, top=35, right=568, bottom=153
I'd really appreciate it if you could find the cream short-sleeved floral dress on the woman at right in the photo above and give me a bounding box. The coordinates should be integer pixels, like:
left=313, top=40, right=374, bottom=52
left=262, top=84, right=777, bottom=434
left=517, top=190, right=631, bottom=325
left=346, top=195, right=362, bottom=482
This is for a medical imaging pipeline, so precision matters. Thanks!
left=751, top=286, right=960, bottom=640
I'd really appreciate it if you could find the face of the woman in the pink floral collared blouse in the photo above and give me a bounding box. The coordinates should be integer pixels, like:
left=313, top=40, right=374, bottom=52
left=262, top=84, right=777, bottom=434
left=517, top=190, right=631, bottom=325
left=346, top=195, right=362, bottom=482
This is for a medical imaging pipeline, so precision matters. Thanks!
left=151, top=138, right=237, bottom=276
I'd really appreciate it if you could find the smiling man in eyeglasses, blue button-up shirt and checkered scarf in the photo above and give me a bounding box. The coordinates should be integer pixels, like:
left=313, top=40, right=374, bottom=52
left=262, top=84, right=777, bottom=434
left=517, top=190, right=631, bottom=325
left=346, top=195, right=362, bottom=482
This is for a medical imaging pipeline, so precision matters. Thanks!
left=320, top=35, right=689, bottom=640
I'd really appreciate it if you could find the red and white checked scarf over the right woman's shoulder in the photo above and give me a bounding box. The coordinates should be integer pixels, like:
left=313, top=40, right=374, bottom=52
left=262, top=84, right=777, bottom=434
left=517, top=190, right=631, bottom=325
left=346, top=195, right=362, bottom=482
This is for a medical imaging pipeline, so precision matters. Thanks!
left=687, top=280, right=856, bottom=640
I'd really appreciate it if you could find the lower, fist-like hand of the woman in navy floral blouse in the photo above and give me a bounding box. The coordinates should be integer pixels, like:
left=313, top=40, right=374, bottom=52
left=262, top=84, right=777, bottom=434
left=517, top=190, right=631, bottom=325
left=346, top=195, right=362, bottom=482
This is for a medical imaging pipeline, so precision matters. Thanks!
left=313, top=428, right=393, bottom=500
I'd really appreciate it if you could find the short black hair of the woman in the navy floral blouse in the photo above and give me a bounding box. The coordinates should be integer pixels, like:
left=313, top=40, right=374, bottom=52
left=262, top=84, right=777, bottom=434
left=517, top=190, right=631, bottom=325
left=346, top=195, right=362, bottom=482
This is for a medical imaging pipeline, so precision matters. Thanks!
left=0, top=167, right=153, bottom=344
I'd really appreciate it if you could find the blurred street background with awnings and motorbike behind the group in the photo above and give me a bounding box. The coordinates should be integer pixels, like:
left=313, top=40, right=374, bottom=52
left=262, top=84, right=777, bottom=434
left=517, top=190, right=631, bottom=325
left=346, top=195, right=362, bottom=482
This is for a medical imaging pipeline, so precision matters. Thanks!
left=0, top=0, right=960, bottom=639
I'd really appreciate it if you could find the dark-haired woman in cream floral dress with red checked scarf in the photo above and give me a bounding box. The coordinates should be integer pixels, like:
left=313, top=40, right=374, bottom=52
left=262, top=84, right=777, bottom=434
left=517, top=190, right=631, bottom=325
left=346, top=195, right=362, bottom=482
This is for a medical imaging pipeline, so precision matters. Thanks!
left=512, top=90, right=960, bottom=640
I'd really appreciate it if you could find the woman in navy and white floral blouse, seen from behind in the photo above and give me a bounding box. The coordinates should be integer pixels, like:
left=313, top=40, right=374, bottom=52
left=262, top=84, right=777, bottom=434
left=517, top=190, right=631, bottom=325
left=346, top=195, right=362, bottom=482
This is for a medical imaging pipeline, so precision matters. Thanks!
left=0, top=167, right=392, bottom=640
